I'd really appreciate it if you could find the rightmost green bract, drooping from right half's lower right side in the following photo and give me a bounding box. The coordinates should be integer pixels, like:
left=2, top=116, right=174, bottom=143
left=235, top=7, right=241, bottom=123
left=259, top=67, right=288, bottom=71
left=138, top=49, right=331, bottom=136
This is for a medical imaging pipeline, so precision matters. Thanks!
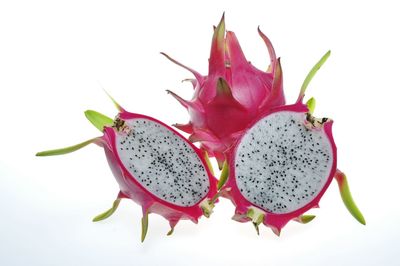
left=335, top=171, right=366, bottom=225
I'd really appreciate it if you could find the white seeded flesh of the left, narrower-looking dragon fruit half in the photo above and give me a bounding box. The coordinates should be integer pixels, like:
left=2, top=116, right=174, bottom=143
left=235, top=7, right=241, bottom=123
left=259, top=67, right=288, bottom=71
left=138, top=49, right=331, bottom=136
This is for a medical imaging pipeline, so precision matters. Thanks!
left=115, top=118, right=210, bottom=207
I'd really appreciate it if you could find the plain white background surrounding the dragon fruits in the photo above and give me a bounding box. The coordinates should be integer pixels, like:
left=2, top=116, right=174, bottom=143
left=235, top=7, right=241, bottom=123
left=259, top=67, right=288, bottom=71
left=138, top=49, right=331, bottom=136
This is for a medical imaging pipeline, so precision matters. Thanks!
left=0, top=0, right=400, bottom=266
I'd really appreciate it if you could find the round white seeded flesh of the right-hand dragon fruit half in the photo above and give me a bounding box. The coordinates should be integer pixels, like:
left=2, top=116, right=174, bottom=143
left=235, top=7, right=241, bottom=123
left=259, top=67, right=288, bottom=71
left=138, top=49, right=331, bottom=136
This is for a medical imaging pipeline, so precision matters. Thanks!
left=235, top=111, right=334, bottom=214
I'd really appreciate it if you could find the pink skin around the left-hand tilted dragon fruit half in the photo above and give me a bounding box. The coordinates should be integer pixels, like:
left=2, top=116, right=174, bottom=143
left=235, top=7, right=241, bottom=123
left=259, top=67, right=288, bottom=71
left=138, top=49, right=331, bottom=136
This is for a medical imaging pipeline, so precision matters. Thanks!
left=101, top=110, right=217, bottom=228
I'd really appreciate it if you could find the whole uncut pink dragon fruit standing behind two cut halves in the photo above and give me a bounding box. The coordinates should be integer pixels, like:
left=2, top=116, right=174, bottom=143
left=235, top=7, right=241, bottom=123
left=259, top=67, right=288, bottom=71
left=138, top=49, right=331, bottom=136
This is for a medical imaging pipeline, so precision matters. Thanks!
left=162, top=15, right=285, bottom=168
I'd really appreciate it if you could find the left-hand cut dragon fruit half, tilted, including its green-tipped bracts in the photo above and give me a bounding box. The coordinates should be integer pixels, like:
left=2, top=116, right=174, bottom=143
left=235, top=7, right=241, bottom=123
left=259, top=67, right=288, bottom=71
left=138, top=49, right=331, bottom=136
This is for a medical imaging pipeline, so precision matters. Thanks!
left=36, top=97, right=217, bottom=242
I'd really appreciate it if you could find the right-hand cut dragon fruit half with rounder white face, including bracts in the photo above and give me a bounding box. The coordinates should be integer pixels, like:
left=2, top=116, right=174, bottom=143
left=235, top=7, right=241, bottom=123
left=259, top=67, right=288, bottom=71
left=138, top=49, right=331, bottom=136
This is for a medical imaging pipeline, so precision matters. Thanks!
left=219, top=52, right=365, bottom=235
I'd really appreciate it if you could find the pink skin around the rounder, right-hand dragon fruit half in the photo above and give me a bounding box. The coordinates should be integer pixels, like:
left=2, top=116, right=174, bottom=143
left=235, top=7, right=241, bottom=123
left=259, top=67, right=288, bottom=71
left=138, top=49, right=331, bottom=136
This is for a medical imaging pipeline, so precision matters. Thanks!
left=223, top=102, right=337, bottom=235
